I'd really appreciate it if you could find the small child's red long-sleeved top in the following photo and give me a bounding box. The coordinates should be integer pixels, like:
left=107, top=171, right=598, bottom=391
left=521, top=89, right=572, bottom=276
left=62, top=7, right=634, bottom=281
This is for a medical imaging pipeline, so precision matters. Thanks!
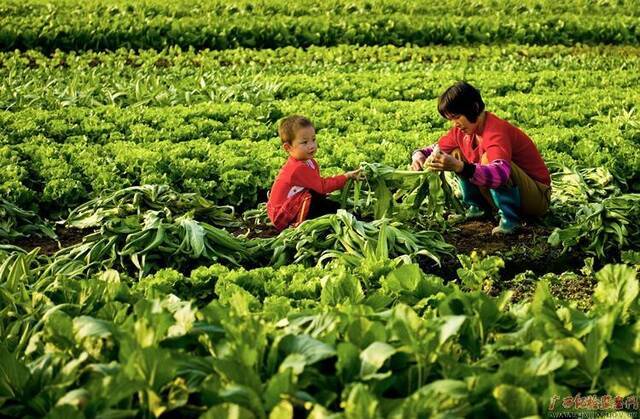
left=267, top=157, right=347, bottom=230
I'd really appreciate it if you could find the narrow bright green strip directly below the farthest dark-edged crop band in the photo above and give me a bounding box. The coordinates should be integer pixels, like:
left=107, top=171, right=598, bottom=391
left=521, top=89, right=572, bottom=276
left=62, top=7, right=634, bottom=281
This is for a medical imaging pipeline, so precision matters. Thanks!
left=6, top=44, right=640, bottom=76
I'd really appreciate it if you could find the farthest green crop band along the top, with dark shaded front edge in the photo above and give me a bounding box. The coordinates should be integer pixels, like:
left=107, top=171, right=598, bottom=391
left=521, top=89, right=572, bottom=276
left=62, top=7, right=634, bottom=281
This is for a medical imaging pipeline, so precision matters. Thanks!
left=0, top=0, right=640, bottom=51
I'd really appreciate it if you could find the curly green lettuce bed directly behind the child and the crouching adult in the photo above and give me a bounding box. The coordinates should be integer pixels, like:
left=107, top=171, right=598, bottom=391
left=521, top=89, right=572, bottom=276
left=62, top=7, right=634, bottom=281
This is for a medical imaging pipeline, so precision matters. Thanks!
left=0, top=95, right=640, bottom=215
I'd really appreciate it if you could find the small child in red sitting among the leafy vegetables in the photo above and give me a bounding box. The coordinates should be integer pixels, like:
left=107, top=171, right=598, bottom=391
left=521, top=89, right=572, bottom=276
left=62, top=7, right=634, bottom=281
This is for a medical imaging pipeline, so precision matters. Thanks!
left=267, top=115, right=361, bottom=230
